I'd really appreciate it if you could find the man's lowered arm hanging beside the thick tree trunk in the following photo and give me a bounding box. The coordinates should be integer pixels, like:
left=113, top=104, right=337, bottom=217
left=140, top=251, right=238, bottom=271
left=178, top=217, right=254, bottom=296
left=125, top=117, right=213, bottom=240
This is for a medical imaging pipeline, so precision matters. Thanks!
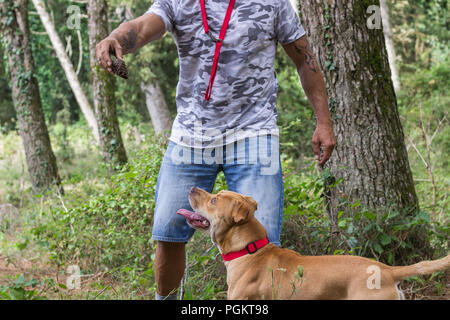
left=283, top=36, right=336, bottom=166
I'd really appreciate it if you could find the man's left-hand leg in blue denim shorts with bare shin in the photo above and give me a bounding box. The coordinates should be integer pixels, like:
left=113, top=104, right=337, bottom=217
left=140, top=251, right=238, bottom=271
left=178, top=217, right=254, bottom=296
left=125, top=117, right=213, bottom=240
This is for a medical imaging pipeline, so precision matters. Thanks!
left=152, top=142, right=218, bottom=299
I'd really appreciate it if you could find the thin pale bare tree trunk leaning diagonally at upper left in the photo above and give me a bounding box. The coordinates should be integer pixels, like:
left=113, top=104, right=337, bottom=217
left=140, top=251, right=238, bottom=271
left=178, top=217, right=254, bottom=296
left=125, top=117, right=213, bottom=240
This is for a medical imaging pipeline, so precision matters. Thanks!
left=32, top=0, right=99, bottom=142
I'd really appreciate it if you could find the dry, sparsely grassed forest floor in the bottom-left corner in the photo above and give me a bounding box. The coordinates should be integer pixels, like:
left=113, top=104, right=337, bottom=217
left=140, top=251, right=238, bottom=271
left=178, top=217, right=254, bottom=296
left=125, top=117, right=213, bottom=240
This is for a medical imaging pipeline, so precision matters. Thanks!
left=0, top=226, right=136, bottom=300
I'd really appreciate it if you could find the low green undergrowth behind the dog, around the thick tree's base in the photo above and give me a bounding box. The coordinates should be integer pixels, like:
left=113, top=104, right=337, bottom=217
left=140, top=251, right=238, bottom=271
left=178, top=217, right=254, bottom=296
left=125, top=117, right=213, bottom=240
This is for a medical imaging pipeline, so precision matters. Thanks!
left=282, top=162, right=450, bottom=265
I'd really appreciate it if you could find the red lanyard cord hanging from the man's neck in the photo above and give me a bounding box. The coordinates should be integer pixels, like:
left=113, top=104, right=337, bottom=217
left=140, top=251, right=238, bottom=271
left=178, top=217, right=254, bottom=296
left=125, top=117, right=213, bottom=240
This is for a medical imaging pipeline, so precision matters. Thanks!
left=200, top=0, right=236, bottom=101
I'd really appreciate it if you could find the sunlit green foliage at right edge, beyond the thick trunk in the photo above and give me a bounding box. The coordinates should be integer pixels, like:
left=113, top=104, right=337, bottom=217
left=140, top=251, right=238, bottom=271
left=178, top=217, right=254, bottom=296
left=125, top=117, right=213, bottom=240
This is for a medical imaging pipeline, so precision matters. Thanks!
left=398, top=56, right=450, bottom=220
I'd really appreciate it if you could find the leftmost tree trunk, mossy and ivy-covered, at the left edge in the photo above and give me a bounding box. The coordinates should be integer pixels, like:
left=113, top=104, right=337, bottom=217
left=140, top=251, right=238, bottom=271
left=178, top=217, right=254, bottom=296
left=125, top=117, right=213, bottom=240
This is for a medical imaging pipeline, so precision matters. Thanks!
left=0, top=0, right=63, bottom=192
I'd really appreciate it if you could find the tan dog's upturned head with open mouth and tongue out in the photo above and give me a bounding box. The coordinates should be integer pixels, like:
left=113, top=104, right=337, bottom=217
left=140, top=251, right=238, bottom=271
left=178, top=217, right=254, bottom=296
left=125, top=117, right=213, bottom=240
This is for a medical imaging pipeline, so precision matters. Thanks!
left=178, top=187, right=258, bottom=250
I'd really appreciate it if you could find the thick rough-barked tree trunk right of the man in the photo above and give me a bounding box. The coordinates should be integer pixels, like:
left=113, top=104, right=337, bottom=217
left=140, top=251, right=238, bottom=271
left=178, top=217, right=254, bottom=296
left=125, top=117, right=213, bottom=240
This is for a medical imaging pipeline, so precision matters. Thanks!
left=300, top=0, right=418, bottom=216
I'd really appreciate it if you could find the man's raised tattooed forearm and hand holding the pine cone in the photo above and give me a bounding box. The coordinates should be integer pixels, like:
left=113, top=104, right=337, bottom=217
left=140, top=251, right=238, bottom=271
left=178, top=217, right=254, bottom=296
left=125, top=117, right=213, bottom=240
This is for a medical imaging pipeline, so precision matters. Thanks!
left=96, top=13, right=165, bottom=74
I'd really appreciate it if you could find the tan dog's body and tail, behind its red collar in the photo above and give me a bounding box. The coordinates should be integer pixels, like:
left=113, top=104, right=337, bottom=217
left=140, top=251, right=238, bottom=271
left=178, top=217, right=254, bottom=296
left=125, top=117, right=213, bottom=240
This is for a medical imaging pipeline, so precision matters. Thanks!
left=225, top=244, right=449, bottom=300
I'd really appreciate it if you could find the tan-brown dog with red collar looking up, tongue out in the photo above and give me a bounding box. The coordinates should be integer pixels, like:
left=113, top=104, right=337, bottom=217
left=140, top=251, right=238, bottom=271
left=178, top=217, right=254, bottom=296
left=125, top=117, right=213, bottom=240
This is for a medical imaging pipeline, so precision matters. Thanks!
left=178, top=187, right=450, bottom=299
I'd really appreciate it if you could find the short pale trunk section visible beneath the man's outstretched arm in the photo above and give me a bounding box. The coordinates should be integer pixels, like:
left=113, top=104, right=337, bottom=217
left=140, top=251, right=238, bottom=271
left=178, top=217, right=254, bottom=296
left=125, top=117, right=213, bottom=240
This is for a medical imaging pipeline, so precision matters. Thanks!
left=141, top=80, right=172, bottom=134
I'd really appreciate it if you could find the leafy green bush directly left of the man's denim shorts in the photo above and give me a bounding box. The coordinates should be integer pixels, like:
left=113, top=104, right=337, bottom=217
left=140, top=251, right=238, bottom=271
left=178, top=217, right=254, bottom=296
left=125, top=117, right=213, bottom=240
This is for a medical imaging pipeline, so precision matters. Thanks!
left=32, top=138, right=162, bottom=278
